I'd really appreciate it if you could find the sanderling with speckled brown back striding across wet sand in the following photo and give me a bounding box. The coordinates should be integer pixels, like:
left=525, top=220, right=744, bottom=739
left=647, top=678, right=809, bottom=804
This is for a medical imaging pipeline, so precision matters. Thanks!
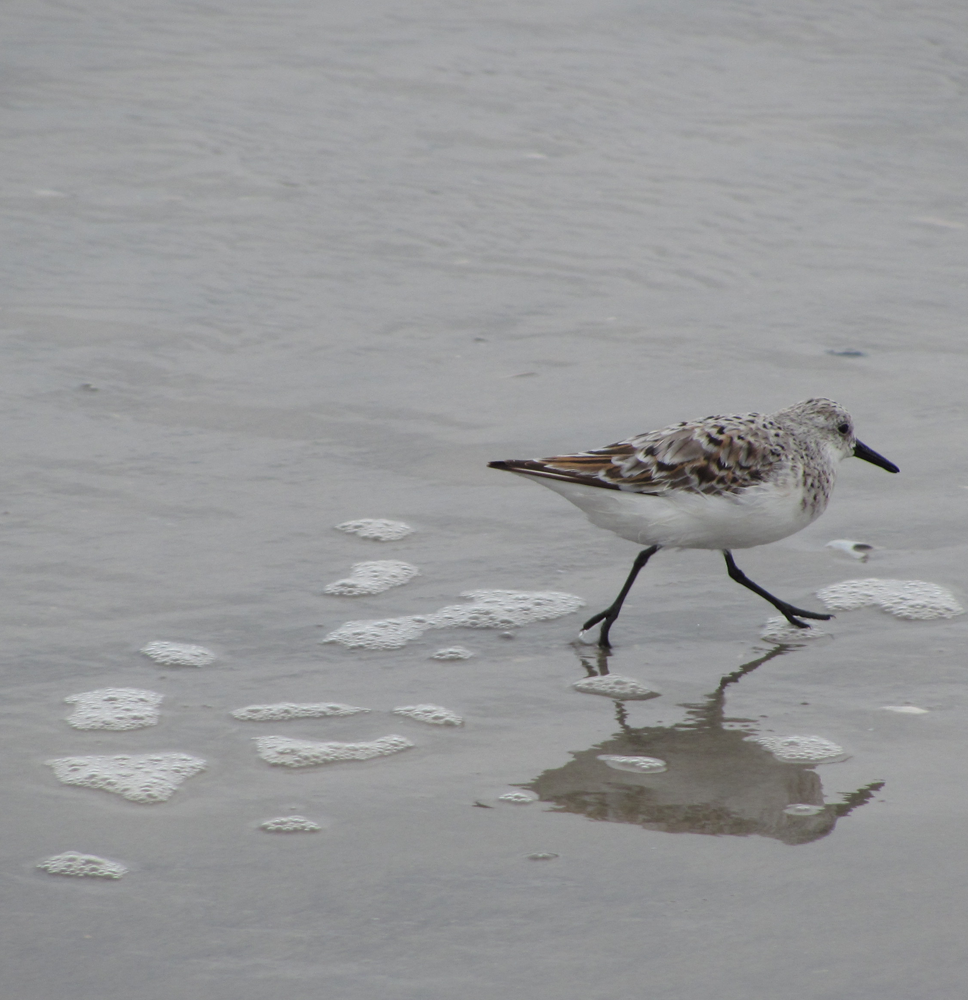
left=489, top=399, right=898, bottom=649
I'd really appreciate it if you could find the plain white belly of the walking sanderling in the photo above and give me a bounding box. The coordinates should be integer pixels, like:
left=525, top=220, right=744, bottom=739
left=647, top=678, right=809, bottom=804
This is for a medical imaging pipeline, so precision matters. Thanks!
left=527, top=476, right=821, bottom=549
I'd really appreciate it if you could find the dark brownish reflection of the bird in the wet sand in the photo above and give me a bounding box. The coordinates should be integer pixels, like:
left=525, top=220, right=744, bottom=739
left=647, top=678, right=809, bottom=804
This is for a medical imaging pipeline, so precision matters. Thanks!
left=522, top=646, right=884, bottom=844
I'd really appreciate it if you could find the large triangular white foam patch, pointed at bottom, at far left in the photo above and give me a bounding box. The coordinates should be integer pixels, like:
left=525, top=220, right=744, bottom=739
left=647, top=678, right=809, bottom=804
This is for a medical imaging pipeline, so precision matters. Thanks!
left=47, top=753, right=205, bottom=805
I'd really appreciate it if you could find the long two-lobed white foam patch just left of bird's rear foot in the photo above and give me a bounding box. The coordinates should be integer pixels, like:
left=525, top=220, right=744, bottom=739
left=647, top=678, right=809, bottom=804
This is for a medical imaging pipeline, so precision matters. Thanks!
left=322, top=590, right=585, bottom=649
